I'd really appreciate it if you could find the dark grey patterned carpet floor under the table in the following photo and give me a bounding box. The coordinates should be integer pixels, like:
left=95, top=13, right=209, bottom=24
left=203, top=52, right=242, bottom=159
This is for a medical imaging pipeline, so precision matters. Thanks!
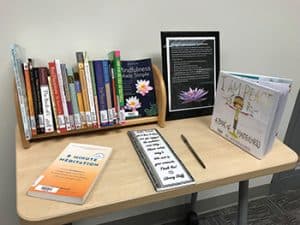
left=167, top=189, right=300, bottom=225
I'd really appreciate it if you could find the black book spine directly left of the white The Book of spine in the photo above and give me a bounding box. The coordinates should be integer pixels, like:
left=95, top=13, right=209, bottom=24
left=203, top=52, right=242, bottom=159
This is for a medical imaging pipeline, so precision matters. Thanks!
left=32, top=68, right=45, bottom=134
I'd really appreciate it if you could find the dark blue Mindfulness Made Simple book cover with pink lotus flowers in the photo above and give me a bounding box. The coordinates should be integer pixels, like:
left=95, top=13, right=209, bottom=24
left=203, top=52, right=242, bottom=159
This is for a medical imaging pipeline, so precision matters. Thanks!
left=121, top=59, right=157, bottom=119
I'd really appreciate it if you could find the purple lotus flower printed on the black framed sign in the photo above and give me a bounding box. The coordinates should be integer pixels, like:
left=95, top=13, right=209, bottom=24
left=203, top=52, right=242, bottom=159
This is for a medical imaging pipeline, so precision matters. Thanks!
left=178, top=87, right=208, bottom=104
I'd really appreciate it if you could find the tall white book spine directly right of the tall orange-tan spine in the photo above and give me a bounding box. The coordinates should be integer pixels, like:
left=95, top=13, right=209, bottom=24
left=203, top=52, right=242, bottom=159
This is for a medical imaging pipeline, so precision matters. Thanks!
left=84, top=52, right=98, bottom=128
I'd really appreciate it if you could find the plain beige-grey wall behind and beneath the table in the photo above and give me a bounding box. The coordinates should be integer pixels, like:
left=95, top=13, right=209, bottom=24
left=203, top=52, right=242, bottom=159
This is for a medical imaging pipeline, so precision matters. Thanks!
left=0, top=0, right=300, bottom=225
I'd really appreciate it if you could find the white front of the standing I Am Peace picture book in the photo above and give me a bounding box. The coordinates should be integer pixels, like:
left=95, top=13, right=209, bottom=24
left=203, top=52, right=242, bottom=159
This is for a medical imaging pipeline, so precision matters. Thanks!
left=211, top=72, right=288, bottom=159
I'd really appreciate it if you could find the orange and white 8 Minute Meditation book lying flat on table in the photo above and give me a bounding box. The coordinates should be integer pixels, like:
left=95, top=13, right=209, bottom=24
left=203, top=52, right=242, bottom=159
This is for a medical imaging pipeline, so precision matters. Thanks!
left=27, top=143, right=112, bottom=204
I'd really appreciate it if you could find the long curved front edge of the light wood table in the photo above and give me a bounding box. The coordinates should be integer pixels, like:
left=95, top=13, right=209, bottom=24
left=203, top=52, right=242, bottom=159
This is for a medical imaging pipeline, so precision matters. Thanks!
left=17, top=149, right=298, bottom=225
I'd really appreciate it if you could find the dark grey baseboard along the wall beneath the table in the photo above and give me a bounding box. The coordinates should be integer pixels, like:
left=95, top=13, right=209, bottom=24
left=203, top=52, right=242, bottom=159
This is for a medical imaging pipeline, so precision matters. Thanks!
left=101, top=184, right=270, bottom=225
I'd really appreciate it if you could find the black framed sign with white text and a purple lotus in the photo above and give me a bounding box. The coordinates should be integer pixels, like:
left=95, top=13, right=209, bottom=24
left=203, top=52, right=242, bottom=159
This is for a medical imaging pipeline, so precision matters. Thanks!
left=161, top=31, right=220, bottom=120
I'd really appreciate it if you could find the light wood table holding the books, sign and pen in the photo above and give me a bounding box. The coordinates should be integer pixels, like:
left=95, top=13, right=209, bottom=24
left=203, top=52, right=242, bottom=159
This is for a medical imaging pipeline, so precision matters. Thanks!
left=16, top=117, right=298, bottom=225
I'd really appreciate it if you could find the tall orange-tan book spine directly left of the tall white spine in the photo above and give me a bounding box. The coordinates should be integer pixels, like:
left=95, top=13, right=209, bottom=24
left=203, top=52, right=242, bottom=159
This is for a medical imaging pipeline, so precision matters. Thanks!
left=76, top=52, right=93, bottom=127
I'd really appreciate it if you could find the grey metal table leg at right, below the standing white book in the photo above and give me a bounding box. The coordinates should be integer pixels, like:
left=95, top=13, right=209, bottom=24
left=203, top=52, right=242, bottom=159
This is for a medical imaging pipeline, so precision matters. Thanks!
left=238, top=180, right=249, bottom=225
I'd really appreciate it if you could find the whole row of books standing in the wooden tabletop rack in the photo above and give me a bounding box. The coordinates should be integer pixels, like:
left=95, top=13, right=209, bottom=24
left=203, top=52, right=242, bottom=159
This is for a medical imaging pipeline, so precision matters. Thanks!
left=11, top=45, right=157, bottom=140
